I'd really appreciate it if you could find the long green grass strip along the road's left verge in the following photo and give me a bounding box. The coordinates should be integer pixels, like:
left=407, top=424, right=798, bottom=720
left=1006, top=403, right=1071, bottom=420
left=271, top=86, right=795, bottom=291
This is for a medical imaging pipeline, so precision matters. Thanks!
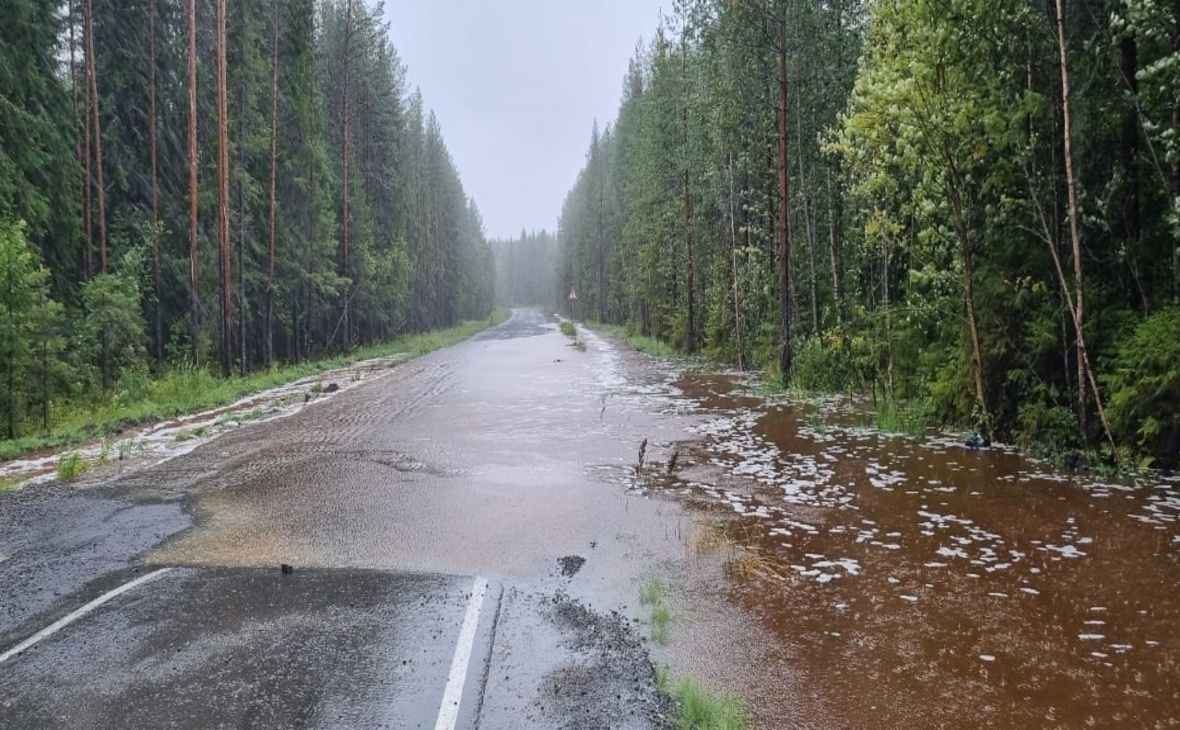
left=0, top=309, right=510, bottom=460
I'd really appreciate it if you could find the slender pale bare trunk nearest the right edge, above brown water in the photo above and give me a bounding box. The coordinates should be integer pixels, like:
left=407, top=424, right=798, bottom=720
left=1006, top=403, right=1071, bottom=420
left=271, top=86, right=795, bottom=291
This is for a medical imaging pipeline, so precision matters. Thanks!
left=1056, top=0, right=1119, bottom=459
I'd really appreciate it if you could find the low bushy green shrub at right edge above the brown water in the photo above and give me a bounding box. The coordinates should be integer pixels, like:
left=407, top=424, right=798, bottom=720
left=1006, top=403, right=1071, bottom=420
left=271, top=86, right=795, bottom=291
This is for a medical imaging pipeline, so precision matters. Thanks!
left=1104, top=307, right=1180, bottom=459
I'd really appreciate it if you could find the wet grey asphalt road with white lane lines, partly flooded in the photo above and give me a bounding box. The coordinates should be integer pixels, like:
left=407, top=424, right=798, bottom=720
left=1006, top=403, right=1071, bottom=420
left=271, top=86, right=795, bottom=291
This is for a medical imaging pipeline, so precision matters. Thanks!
left=0, top=310, right=682, bottom=730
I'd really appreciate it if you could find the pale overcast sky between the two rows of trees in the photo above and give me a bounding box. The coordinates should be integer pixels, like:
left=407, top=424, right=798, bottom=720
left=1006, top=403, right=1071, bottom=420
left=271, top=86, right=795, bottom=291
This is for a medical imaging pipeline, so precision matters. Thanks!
left=385, top=0, right=671, bottom=238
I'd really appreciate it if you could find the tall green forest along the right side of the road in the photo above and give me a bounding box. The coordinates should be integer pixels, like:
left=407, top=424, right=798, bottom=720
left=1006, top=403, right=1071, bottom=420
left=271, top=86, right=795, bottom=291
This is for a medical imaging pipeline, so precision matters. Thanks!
left=558, top=0, right=1180, bottom=461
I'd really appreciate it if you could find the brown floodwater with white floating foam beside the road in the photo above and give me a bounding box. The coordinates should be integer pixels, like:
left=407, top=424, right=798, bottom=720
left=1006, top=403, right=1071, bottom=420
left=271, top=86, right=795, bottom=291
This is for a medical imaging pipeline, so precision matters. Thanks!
left=656, top=373, right=1180, bottom=728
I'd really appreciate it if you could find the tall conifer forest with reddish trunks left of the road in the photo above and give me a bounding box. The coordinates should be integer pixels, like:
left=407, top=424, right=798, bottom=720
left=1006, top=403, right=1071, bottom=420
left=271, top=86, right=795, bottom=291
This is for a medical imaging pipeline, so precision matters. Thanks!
left=0, top=0, right=494, bottom=438
